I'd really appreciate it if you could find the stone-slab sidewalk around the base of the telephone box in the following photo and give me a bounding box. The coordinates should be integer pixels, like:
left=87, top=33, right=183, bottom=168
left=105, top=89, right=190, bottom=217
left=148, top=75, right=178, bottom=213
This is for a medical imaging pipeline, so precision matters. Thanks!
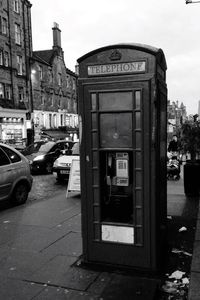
left=0, top=183, right=200, bottom=300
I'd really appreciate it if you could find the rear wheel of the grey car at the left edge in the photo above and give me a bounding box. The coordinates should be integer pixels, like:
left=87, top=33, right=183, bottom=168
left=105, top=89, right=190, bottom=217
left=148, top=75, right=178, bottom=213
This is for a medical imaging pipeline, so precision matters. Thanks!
left=11, top=182, right=28, bottom=205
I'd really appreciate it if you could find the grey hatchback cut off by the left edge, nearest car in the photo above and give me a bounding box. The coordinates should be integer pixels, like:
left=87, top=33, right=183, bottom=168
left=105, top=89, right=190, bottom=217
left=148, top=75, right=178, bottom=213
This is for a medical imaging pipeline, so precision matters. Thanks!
left=0, top=143, right=33, bottom=205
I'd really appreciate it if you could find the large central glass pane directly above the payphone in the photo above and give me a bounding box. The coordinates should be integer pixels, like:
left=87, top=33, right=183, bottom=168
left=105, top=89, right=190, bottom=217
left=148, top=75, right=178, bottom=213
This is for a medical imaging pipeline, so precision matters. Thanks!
left=100, top=113, right=132, bottom=148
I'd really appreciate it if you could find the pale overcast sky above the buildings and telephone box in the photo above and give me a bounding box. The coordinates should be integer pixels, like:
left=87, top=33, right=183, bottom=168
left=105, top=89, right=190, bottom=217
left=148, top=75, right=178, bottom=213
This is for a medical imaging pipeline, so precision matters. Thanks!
left=30, top=0, right=200, bottom=115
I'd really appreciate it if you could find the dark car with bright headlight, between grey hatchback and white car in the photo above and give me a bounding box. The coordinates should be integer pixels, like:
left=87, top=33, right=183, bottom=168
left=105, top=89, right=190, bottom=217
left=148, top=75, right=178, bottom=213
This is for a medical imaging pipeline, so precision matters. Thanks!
left=27, top=140, right=74, bottom=174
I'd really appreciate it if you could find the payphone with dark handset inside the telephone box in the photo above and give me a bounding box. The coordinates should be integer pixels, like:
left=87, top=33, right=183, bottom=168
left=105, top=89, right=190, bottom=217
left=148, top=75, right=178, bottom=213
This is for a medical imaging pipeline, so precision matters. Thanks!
left=106, top=152, right=129, bottom=186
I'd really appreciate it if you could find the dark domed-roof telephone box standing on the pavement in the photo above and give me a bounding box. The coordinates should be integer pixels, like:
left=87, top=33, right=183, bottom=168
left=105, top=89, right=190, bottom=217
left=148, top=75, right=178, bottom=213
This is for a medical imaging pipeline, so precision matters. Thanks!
left=78, top=44, right=167, bottom=271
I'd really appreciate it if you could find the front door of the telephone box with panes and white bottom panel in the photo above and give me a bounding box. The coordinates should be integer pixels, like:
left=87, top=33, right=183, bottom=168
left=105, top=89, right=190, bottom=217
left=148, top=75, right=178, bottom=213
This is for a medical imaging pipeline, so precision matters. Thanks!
left=79, top=44, right=166, bottom=270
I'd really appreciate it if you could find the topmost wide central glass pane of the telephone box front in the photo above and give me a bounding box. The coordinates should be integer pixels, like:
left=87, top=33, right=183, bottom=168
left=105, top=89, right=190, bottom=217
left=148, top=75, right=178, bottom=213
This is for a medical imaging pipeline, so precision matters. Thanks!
left=99, top=92, right=133, bottom=110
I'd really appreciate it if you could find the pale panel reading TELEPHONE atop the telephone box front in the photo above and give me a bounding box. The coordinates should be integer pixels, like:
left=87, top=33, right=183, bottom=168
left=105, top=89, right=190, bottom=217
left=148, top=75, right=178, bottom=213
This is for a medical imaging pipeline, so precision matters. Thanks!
left=88, top=61, right=146, bottom=76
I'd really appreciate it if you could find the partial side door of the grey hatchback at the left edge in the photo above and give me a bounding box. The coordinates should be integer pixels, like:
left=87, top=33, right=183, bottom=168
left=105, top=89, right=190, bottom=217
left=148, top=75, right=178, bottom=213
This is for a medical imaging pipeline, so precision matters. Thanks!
left=0, top=147, right=14, bottom=200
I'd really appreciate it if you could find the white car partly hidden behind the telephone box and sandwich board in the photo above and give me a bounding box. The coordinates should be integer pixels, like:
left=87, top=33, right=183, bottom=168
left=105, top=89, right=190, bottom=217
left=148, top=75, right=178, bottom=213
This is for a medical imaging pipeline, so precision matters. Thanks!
left=53, top=142, right=80, bottom=181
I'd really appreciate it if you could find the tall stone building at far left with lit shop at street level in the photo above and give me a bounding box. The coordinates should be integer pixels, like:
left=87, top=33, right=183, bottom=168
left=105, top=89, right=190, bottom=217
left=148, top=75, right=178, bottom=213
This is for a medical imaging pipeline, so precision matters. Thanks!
left=0, top=0, right=33, bottom=143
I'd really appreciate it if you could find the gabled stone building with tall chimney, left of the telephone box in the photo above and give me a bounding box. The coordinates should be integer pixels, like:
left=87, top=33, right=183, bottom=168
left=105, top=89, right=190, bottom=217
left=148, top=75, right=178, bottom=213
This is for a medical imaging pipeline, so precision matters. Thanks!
left=31, top=23, right=78, bottom=139
